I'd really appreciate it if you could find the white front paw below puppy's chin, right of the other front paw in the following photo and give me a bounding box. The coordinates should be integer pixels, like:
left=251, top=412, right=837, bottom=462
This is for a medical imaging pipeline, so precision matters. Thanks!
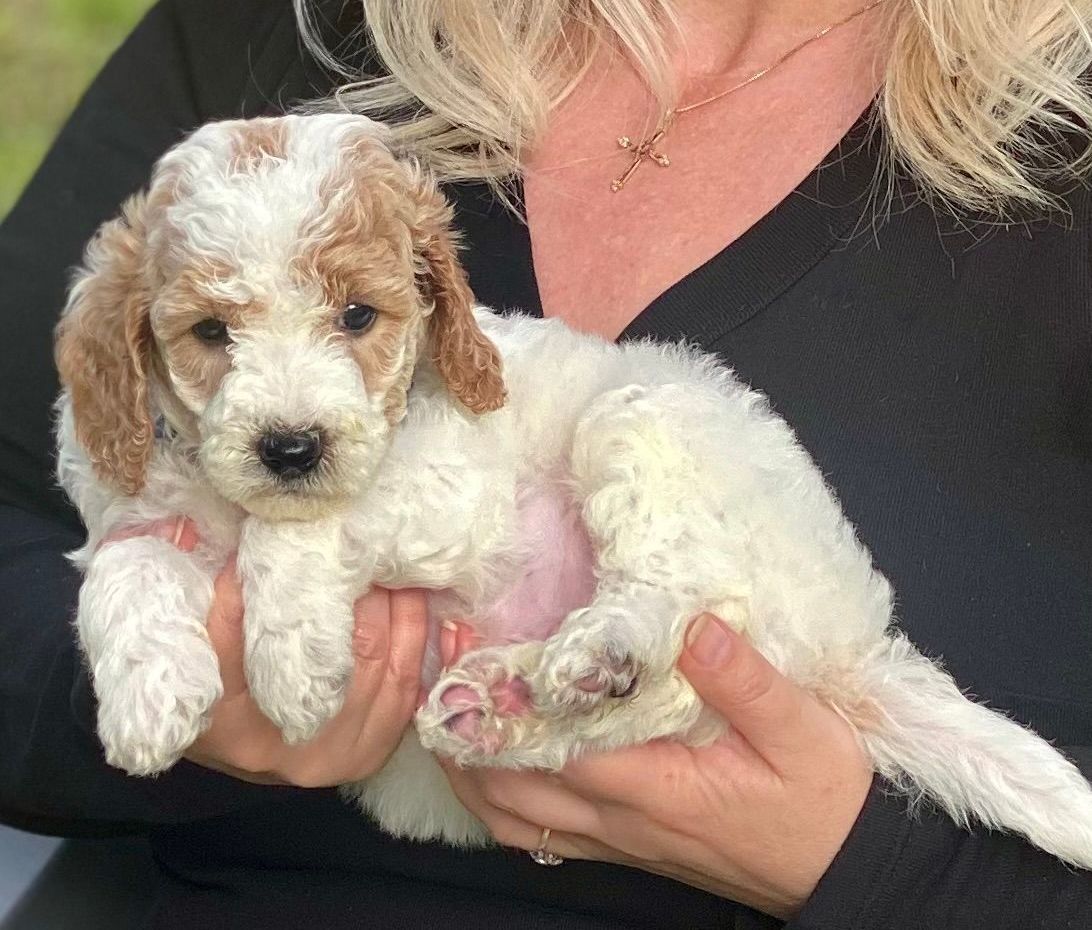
left=246, top=608, right=353, bottom=744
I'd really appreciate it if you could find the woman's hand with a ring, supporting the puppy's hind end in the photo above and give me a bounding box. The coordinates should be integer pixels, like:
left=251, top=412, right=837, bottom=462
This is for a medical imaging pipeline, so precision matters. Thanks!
left=443, top=617, right=873, bottom=918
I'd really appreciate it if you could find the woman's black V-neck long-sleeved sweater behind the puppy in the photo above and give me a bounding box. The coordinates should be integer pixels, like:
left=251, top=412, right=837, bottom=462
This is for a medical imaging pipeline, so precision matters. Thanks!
left=0, top=0, right=1092, bottom=930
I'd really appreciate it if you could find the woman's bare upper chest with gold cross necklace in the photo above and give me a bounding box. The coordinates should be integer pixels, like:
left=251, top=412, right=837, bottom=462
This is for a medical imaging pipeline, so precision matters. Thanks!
left=523, top=49, right=875, bottom=338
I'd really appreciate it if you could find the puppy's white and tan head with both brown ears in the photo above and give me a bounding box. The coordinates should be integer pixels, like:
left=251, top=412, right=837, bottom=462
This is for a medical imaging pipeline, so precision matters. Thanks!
left=57, top=116, right=505, bottom=518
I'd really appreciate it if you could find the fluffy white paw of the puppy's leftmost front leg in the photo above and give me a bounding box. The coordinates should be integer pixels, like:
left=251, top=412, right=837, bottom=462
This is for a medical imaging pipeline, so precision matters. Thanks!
left=95, top=639, right=223, bottom=775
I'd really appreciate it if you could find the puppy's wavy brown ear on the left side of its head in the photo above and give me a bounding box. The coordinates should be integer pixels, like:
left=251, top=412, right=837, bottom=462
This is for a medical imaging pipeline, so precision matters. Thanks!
left=55, top=195, right=155, bottom=494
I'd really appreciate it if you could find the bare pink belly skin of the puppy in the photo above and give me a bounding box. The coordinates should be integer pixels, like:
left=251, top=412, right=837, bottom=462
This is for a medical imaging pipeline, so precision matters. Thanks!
left=473, top=484, right=595, bottom=645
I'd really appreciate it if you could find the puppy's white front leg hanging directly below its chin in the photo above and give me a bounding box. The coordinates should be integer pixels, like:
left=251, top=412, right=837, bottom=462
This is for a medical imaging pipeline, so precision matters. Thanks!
left=239, top=517, right=354, bottom=743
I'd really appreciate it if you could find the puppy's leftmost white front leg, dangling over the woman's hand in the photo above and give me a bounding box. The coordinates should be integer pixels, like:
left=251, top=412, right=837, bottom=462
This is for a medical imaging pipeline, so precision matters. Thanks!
left=76, top=537, right=222, bottom=775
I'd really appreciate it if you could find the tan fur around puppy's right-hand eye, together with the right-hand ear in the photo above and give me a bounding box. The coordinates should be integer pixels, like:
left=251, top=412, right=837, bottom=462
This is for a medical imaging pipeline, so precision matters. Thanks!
left=255, top=121, right=506, bottom=422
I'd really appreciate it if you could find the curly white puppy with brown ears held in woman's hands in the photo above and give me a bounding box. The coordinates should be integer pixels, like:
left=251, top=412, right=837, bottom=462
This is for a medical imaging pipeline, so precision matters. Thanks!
left=57, top=116, right=1092, bottom=868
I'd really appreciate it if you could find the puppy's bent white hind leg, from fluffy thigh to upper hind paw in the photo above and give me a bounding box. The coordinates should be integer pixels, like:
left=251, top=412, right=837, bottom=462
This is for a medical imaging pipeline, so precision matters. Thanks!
left=534, top=385, right=752, bottom=724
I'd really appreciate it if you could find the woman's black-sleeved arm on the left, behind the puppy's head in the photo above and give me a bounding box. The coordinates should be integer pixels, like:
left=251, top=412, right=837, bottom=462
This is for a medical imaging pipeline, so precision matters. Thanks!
left=0, top=0, right=297, bottom=833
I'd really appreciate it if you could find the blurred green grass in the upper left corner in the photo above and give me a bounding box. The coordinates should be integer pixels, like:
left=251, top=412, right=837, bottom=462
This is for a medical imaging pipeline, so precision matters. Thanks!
left=0, top=0, right=155, bottom=217
